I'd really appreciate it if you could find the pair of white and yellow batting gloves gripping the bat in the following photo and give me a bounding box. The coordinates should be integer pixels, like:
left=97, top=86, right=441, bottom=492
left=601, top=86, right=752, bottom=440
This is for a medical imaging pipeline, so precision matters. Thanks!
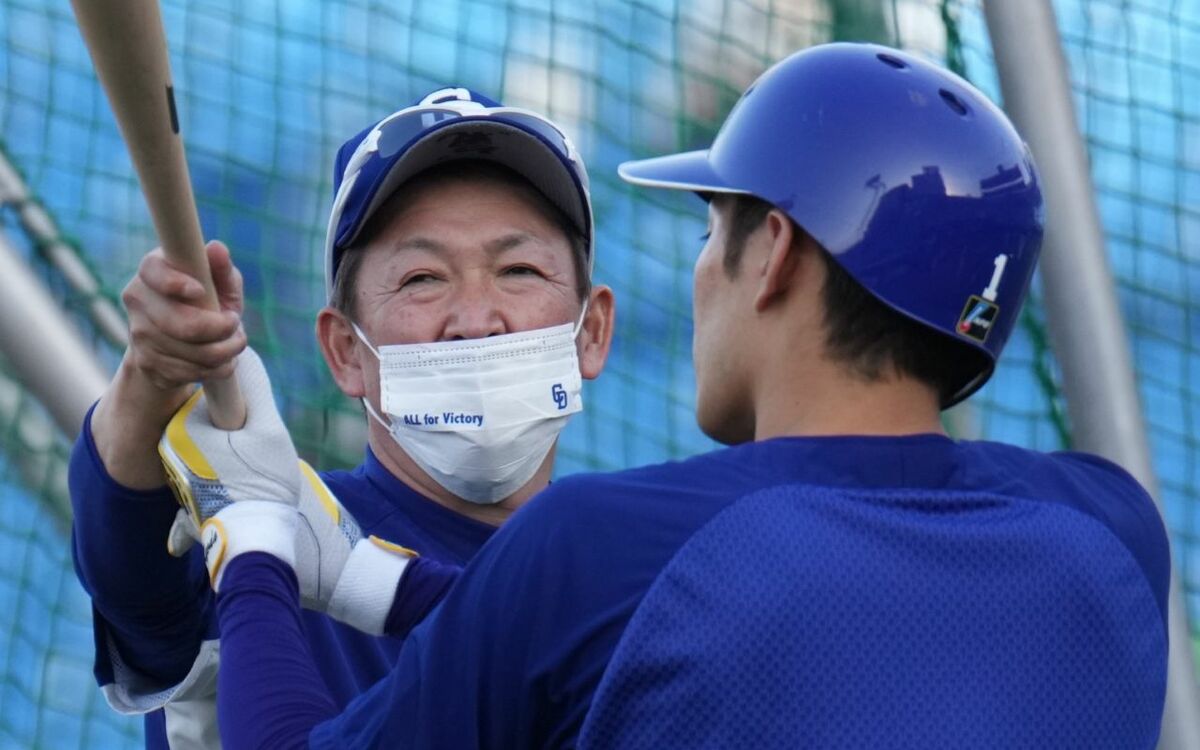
left=158, top=349, right=416, bottom=635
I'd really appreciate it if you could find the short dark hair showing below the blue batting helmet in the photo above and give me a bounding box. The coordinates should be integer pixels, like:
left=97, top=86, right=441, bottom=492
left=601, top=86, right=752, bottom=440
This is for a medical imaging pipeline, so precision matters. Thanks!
left=724, top=196, right=991, bottom=404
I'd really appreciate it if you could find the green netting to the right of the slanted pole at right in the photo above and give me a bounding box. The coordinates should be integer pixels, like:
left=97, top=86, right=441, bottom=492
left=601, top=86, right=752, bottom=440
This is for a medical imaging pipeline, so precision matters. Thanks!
left=1061, top=2, right=1200, bottom=656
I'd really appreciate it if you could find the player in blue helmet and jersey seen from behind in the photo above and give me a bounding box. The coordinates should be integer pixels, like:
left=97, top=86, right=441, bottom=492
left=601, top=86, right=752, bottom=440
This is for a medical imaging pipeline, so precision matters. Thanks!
left=192, top=44, right=1170, bottom=748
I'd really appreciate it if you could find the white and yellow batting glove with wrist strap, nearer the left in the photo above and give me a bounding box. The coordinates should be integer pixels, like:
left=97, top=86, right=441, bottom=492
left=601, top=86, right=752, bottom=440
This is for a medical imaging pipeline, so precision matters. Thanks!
left=158, top=349, right=301, bottom=590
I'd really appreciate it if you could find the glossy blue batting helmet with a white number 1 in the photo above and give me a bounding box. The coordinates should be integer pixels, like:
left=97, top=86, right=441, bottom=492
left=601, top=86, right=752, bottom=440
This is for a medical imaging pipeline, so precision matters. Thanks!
left=619, top=43, right=1043, bottom=406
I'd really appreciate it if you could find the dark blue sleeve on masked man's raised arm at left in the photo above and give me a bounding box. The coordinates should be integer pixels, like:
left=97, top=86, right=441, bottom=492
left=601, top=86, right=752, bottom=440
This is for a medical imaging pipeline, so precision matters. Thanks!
left=68, top=400, right=217, bottom=713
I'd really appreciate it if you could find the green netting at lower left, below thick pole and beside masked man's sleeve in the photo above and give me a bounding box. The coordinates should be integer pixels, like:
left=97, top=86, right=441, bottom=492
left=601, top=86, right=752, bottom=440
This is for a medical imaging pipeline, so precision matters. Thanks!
left=0, top=357, right=140, bottom=748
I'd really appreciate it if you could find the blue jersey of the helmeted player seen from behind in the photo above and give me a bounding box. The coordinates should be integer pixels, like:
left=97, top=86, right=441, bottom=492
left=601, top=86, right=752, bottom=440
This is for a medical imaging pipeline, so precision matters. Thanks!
left=211, top=436, right=1170, bottom=748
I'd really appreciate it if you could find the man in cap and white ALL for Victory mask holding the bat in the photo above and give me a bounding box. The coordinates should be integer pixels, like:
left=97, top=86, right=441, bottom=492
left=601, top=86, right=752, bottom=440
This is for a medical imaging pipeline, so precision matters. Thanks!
left=71, top=89, right=613, bottom=748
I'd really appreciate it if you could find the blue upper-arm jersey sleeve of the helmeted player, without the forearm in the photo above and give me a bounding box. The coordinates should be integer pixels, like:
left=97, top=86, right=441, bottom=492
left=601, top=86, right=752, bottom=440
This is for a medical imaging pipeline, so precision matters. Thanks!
left=307, top=481, right=670, bottom=749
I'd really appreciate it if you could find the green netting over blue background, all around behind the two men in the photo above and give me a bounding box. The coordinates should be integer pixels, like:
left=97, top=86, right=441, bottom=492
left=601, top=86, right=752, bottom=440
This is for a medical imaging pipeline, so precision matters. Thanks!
left=0, top=0, right=1200, bottom=748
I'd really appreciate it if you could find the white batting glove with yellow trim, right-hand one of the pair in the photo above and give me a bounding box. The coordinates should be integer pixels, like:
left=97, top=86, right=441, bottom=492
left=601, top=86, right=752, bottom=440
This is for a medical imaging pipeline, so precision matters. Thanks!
left=295, top=461, right=416, bottom=635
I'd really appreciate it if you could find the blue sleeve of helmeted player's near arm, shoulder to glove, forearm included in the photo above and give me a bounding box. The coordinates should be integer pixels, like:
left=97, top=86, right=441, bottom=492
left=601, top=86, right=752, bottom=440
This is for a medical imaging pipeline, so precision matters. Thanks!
left=218, top=468, right=713, bottom=749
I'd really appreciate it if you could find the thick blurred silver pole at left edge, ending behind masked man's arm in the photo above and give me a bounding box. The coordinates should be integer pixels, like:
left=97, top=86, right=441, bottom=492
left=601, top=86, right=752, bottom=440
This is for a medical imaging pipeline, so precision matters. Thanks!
left=0, top=232, right=108, bottom=438
